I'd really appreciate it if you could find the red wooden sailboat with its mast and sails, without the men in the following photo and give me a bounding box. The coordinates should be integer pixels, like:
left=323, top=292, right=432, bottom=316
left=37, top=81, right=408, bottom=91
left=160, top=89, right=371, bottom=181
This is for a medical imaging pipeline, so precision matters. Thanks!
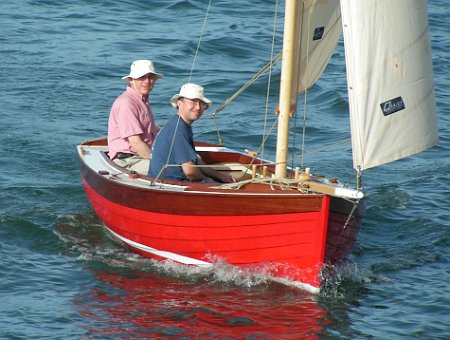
left=77, top=0, right=438, bottom=292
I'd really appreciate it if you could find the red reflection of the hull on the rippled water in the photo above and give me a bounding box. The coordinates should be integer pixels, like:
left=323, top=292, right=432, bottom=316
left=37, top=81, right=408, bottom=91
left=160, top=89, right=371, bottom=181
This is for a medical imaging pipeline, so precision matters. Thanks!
left=76, top=272, right=327, bottom=339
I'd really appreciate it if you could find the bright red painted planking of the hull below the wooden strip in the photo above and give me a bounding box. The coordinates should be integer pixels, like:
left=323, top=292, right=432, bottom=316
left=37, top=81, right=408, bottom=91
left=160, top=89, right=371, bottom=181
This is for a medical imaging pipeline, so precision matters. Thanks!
left=84, top=179, right=329, bottom=287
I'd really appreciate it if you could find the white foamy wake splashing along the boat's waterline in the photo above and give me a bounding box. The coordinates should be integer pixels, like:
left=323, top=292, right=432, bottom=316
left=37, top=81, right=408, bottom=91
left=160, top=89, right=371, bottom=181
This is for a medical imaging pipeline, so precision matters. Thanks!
left=55, top=214, right=366, bottom=294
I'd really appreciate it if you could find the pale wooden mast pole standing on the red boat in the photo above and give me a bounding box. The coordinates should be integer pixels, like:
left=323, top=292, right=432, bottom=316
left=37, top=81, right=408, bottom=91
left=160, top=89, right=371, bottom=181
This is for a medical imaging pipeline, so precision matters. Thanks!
left=275, top=0, right=298, bottom=178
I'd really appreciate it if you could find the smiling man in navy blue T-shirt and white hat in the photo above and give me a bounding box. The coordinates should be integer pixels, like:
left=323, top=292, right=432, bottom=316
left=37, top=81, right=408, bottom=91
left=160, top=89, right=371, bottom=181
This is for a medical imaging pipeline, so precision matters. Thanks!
left=149, top=83, right=234, bottom=183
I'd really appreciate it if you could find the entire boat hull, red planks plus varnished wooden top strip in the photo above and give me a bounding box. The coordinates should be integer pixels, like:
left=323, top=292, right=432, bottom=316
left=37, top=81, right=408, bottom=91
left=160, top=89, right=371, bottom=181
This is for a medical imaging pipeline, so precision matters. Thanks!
left=80, top=139, right=359, bottom=290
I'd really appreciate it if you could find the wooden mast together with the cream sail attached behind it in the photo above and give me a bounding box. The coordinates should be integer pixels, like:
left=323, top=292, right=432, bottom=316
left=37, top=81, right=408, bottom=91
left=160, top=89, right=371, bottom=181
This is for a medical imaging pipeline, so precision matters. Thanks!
left=275, top=0, right=342, bottom=178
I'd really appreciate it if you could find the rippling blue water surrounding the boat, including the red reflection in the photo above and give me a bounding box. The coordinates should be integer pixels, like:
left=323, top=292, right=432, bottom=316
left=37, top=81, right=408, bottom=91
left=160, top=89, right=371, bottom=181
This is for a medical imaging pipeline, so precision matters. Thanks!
left=0, top=0, right=450, bottom=339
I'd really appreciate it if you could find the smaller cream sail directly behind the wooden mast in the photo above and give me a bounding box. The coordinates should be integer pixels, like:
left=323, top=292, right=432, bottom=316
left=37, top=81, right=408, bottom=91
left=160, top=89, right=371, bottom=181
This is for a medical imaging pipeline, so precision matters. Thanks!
left=294, top=0, right=342, bottom=93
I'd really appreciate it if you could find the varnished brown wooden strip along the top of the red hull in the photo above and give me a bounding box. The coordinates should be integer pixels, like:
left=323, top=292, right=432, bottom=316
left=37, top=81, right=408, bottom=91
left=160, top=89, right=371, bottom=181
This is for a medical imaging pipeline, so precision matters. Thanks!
left=80, top=153, right=324, bottom=216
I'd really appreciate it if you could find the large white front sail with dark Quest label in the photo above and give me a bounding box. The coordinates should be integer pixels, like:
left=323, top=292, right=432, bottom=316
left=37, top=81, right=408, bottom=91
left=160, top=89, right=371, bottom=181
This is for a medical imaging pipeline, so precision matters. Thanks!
left=341, top=0, right=438, bottom=170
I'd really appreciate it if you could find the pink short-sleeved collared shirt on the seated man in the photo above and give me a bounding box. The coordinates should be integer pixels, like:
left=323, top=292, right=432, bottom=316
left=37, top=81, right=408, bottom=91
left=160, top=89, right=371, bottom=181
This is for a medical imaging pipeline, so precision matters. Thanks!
left=108, top=87, right=158, bottom=159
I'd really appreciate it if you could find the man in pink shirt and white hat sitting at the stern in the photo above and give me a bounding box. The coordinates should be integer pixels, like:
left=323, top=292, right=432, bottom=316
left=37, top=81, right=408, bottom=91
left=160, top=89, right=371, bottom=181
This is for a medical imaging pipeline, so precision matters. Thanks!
left=108, top=60, right=163, bottom=175
